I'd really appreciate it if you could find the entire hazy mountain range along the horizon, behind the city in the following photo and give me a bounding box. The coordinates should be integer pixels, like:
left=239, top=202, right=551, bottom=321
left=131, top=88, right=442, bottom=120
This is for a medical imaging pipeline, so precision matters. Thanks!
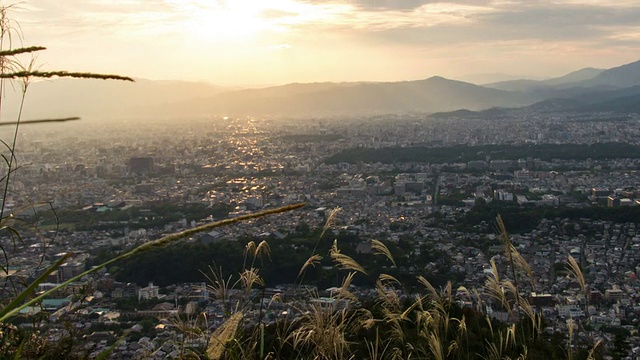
left=2, top=61, right=640, bottom=121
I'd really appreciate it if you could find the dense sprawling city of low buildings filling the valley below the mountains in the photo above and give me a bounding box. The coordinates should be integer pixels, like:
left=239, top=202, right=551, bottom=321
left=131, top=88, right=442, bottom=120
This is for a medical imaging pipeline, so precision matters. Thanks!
left=4, top=107, right=640, bottom=358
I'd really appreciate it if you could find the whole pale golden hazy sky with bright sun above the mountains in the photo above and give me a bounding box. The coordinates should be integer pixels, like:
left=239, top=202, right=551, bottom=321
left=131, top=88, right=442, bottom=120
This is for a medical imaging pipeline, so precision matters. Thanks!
left=11, top=0, right=640, bottom=85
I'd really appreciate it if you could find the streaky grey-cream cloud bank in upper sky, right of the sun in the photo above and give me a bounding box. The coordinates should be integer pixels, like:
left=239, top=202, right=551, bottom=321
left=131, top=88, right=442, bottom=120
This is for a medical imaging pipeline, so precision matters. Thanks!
left=302, top=1, right=640, bottom=46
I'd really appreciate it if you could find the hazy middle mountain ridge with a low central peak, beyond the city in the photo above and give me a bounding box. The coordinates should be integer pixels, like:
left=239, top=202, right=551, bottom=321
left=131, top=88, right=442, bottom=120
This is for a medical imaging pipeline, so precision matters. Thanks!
left=165, top=77, right=530, bottom=116
